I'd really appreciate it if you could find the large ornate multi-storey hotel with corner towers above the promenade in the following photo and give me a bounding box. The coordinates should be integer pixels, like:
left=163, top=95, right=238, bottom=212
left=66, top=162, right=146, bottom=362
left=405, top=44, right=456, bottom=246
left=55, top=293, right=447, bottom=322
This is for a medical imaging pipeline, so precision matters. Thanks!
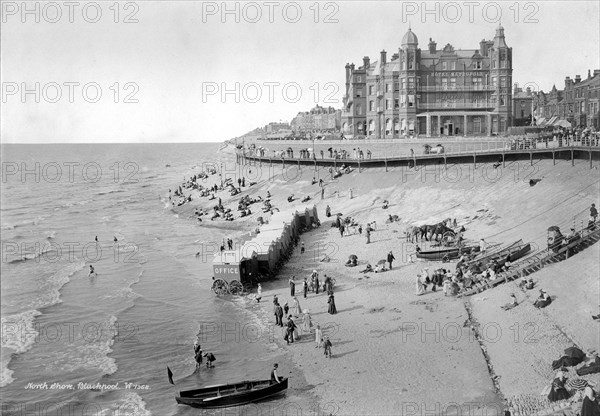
left=341, top=26, right=512, bottom=139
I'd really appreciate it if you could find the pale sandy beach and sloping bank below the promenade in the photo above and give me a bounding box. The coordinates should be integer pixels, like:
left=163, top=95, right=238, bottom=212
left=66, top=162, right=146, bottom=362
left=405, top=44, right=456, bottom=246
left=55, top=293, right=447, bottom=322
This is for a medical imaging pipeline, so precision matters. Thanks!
left=172, top=148, right=599, bottom=414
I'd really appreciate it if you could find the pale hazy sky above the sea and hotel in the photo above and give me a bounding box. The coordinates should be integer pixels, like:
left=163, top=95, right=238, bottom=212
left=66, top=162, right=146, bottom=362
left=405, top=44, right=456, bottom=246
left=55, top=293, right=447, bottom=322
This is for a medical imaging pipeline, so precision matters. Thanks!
left=0, top=0, right=600, bottom=143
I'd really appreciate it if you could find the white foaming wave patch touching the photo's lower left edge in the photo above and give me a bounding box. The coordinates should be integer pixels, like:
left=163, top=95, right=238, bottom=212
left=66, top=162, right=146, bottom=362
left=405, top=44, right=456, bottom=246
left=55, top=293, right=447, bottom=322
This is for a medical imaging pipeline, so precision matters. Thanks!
left=0, top=309, right=41, bottom=387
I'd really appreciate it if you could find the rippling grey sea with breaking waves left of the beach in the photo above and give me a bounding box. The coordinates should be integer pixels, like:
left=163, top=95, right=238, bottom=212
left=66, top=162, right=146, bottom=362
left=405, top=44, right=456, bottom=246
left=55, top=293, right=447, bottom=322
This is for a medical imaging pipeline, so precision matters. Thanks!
left=0, top=143, right=314, bottom=416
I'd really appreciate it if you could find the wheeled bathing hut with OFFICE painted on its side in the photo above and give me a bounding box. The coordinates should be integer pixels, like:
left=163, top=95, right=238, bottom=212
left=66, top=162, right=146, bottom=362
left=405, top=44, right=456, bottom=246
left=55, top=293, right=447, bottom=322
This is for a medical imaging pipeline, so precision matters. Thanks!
left=212, top=247, right=258, bottom=295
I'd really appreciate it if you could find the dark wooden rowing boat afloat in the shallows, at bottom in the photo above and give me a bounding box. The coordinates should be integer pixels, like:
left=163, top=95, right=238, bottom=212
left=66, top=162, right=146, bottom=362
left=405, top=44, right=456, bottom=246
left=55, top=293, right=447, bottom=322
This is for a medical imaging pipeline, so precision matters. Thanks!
left=175, top=378, right=288, bottom=409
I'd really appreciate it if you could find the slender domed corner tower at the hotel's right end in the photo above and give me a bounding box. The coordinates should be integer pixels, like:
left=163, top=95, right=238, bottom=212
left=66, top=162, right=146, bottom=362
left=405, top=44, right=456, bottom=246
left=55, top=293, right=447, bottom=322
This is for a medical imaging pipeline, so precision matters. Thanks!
left=490, top=25, right=513, bottom=133
